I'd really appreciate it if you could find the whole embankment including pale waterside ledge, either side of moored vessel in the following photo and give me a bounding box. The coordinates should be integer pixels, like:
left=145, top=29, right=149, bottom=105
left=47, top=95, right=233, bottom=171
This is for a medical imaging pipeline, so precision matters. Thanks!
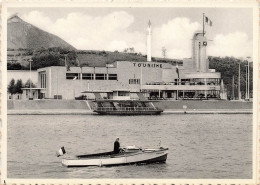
left=7, top=100, right=253, bottom=115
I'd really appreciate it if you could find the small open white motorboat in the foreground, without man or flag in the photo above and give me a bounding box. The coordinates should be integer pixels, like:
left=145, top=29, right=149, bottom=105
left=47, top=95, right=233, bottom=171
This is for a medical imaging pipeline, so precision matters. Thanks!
left=62, top=147, right=168, bottom=167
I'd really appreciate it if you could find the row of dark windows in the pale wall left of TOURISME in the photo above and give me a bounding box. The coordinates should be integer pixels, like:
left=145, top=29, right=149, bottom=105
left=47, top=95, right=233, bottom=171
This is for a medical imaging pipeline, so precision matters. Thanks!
left=66, top=73, right=117, bottom=80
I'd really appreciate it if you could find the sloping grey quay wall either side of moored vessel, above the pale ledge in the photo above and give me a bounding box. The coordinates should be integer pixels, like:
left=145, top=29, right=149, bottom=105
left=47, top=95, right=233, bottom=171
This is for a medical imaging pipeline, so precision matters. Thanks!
left=7, top=100, right=253, bottom=110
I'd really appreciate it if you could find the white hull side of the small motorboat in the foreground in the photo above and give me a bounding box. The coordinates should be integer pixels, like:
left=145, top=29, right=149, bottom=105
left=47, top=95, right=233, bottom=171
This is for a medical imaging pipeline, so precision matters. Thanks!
left=62, top=149, right=168, bottom=167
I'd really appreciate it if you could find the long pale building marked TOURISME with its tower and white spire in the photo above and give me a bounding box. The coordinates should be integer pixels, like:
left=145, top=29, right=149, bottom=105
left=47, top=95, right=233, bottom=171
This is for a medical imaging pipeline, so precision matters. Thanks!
left=7, top=21, right=224, bottom=100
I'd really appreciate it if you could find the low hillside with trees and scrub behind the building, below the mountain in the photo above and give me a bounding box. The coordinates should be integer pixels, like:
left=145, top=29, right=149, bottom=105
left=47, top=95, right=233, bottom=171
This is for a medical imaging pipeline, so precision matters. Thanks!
left=7, top=47, right=182, bottom=70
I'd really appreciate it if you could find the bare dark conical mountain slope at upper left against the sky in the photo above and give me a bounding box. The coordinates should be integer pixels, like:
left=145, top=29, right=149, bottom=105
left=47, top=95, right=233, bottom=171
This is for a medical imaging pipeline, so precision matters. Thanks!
left=7, top=15, right=76, bottom=50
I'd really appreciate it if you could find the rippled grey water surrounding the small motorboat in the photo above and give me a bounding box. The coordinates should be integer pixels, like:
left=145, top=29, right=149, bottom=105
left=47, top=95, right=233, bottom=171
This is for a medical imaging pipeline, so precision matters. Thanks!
left=7, top=114, right=252, bottom=179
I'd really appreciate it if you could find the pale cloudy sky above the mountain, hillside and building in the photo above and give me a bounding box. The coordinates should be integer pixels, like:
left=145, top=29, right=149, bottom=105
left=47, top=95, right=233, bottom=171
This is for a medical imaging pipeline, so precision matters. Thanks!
left=8, top=7, right=253, bottom=59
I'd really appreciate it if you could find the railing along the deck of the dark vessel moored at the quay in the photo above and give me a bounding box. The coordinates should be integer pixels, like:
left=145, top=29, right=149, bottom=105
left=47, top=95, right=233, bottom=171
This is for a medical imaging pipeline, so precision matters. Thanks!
left=94, top=107, right=158, bottom=111
